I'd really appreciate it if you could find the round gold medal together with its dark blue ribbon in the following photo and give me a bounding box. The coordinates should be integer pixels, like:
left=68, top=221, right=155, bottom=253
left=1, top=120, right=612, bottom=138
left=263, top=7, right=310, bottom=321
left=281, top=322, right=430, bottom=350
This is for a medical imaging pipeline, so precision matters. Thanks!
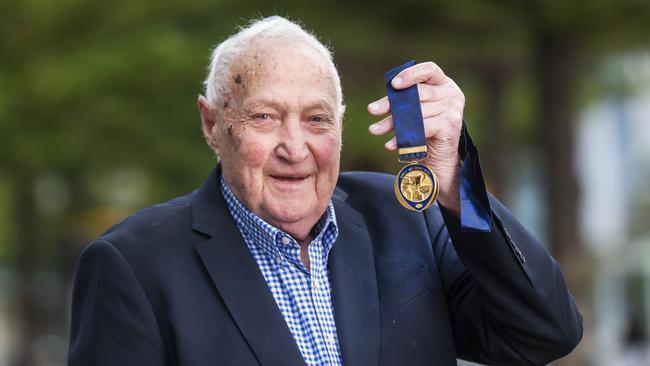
left=385, top=61, right=438, bottom=212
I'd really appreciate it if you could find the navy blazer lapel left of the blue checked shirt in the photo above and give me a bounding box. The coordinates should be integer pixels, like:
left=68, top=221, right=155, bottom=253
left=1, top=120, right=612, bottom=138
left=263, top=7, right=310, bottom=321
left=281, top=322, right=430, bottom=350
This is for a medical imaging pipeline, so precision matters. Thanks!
left=192, top=169, right=305, bottom=365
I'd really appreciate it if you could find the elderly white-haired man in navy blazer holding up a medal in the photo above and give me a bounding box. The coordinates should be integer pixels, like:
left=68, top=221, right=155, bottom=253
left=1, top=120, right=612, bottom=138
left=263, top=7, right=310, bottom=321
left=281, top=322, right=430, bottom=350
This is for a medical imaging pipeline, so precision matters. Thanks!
left=70, top=17, right=582, bottom=366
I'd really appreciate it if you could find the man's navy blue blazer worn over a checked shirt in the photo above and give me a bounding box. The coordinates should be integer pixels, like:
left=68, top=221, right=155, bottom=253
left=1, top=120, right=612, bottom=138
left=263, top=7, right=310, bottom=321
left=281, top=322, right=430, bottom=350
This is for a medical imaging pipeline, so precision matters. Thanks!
left=69, top=168, right=582, bottom=366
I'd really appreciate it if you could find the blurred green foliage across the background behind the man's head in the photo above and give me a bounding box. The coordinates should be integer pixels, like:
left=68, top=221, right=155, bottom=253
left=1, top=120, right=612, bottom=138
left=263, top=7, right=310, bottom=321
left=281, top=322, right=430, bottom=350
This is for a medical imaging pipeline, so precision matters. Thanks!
left=0, top=0, right=650, bottom=258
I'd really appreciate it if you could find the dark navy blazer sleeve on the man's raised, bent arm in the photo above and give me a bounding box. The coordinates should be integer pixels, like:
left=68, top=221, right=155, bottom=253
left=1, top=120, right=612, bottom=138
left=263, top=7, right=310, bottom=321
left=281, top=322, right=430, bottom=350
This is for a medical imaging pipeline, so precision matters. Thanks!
left=427, top=195, right=582, bottom=365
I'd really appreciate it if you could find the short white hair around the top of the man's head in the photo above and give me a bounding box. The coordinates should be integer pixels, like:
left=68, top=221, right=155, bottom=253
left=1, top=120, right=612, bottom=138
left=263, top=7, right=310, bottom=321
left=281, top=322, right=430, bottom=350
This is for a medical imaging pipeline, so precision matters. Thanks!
left=203, top=15, right=343, bottom=110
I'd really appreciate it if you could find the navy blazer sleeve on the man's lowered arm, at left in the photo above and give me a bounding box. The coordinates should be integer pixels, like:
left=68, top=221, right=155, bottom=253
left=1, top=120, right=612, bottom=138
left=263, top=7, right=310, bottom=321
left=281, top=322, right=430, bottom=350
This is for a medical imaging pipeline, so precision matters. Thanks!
left=68, top=240, right=168, bottom=366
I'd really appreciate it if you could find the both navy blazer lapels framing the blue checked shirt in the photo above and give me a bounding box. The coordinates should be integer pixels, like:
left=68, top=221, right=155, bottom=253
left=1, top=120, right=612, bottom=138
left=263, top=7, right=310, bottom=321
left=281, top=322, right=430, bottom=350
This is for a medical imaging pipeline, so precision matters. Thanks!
left=192, top=166, right=379, bottom=365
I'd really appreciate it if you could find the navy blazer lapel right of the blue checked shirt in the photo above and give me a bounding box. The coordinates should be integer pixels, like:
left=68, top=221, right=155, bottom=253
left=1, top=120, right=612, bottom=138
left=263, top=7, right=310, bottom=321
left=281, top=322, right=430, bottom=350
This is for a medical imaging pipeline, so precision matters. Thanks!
left=328, top=198, right=380, bottom=365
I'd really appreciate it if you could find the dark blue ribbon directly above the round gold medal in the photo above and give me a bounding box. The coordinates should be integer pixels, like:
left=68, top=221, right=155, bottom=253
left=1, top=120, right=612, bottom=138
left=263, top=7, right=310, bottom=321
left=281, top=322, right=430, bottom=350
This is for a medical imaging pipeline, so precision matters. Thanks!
left=384, top=61, right=427, bottom=161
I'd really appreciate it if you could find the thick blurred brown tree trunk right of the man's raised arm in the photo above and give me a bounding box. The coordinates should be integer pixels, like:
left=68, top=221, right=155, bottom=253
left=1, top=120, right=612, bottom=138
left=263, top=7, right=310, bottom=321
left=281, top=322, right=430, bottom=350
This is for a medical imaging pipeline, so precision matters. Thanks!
left=534, top=30, right=590, bottom=365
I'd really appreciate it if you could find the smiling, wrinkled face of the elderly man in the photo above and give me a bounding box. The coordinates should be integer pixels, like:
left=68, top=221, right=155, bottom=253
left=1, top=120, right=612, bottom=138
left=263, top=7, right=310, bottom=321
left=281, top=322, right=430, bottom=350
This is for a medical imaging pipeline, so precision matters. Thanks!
left=204, top=44, right=342, bottom=239
